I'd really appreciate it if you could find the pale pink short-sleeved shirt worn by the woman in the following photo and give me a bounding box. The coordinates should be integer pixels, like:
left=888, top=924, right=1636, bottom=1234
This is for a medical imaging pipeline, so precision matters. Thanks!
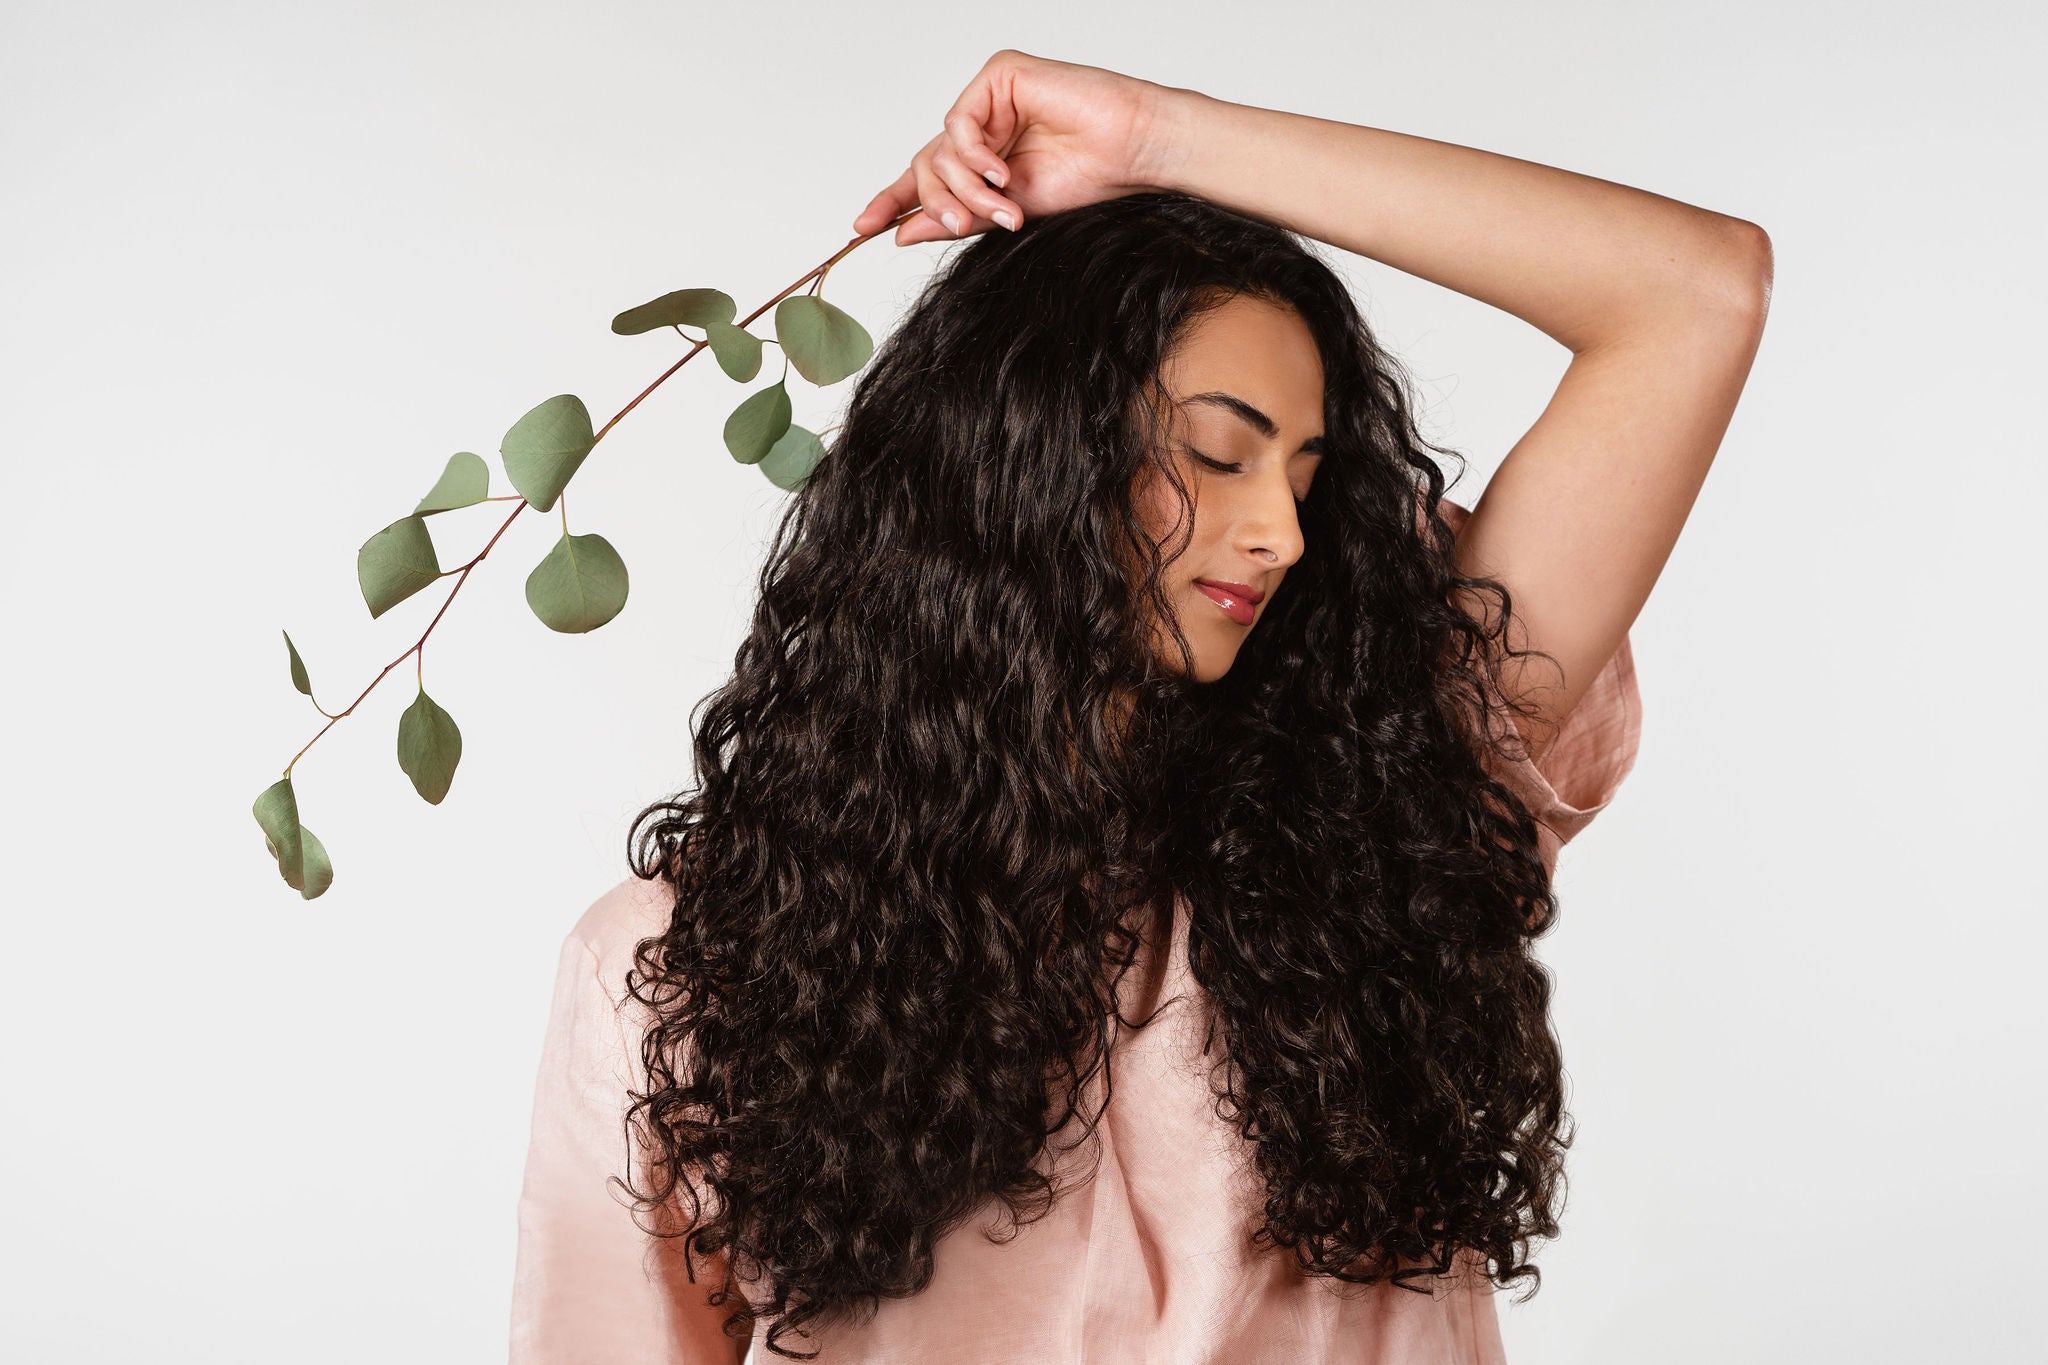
left=510, top=503, right=1640, bottom=1365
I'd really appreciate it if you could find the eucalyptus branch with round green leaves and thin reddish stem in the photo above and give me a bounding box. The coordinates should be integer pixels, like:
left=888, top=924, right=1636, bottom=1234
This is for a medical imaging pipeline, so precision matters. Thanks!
left=252, top=209, right=918, bottom=900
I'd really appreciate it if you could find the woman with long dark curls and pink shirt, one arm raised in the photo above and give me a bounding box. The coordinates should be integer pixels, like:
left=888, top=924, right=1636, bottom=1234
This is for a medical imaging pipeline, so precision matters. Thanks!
left=512, top=51, right=1769, bottom=1365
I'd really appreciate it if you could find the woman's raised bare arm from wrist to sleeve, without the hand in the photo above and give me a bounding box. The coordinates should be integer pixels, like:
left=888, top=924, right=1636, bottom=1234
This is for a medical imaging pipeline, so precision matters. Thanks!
left=1145, top=88, right=1772, bottom=753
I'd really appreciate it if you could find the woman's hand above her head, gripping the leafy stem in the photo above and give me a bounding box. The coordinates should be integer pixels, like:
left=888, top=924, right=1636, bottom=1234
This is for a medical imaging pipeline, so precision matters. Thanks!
left=854, top=47, right=1194, bottom=246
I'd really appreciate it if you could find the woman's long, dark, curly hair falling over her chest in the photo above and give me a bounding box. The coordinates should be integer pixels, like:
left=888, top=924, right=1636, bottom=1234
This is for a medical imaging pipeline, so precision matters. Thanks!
left=627, top=192, right=1569, bottom=1359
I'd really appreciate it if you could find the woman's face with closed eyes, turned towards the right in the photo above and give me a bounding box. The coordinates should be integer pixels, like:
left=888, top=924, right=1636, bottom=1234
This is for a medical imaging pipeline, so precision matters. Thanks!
left=1137, top=295, right=1323, bottom=681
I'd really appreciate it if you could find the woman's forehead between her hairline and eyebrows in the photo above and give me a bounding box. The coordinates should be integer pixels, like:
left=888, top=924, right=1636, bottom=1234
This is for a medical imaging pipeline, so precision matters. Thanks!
left=1159, top=295, right=1323, bottom=434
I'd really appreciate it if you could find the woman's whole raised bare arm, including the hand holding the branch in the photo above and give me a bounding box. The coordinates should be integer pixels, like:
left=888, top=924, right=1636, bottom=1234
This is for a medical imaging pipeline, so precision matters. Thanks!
left=854, top=49, right=1772, bottom=757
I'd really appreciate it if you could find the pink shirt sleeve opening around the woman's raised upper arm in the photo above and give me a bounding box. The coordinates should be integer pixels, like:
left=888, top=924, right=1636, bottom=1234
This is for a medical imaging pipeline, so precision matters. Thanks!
left=1440, top=499, right=1642, bottom=870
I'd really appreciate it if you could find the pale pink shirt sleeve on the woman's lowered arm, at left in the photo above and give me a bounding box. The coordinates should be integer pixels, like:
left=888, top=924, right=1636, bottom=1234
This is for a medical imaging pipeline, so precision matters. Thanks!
left=510, top=888, right=752, bottom=1365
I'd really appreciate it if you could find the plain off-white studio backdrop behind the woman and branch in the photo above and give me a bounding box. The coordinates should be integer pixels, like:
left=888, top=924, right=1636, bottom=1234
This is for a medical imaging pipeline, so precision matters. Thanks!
left=0, top=0, right=2048, bottom=1365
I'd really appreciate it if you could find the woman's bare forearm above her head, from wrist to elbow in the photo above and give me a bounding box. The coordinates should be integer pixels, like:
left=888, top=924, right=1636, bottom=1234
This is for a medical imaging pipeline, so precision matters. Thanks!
left=1147, top=86, right=1769, bottom=354
